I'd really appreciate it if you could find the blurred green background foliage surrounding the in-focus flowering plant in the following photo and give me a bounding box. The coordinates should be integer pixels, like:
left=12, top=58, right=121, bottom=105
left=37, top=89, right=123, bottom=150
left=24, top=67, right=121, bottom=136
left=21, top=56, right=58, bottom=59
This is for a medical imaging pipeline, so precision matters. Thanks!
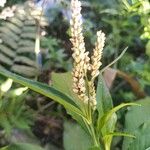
left=0, top=0, right=150, bottom=150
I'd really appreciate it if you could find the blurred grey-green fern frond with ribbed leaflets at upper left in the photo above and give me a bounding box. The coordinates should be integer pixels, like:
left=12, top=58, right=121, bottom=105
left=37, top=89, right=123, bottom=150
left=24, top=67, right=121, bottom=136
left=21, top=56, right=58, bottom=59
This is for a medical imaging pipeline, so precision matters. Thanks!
left=0, top=3, right=47, bottom=77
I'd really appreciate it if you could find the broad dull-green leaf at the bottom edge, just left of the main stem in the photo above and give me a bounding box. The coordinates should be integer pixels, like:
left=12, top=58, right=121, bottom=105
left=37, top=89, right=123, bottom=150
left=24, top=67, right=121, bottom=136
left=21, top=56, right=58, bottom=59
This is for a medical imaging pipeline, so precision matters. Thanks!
left=63, top=122, right=92, bottom=150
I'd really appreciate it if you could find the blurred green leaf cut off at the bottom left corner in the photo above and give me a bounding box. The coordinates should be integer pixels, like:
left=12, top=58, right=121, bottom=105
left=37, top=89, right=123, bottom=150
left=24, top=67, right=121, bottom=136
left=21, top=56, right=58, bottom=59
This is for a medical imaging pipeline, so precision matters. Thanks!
left=0, top=143, right=44, bottom=150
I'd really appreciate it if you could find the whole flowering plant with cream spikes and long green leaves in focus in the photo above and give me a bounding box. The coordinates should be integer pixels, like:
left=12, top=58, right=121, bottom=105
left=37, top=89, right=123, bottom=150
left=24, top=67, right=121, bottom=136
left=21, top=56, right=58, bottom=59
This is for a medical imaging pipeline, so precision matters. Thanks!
left=0, top=0, right=137, bottom=150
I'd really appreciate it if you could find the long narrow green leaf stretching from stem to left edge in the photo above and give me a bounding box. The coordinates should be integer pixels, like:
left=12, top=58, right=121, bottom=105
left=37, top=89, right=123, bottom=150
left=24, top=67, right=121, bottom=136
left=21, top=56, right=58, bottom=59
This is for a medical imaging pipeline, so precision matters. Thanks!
left=0, top=68, right=82, bottom=116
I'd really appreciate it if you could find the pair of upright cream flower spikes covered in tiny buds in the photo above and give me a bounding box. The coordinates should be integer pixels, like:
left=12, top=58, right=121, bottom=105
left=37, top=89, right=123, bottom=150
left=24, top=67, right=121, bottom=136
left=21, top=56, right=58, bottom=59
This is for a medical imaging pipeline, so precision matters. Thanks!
left=70, top=0, right=105, bottom=108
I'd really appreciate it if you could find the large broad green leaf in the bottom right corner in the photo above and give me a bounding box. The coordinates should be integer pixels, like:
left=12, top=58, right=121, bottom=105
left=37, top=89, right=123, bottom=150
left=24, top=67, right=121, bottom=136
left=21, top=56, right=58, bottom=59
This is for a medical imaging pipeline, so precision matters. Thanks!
left=122, top=97, right=150, bottom=150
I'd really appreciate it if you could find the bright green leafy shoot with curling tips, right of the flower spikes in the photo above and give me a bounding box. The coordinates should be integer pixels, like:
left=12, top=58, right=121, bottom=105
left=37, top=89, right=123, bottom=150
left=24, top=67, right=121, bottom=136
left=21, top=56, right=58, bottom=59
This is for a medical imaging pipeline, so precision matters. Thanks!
left=96, top=75, right=137, bottom=150
